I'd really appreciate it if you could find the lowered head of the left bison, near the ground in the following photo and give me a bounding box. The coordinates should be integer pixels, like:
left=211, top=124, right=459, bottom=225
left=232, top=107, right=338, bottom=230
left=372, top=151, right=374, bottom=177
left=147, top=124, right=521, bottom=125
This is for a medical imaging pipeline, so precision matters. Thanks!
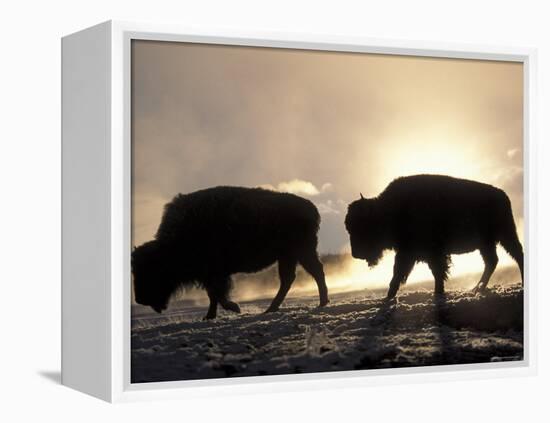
left=132, top=241, right=175, bottom=313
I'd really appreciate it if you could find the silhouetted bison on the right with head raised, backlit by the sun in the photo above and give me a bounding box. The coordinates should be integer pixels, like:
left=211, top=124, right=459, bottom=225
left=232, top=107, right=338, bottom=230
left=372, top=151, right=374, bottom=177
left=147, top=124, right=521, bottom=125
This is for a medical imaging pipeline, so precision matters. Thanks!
left=346, top=175, right=523, bottom=298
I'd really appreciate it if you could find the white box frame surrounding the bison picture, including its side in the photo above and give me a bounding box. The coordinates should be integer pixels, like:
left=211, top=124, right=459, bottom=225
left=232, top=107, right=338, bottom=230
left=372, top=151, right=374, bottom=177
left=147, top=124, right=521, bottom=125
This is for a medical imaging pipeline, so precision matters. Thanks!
left=62, top=21, right=537, bottom=402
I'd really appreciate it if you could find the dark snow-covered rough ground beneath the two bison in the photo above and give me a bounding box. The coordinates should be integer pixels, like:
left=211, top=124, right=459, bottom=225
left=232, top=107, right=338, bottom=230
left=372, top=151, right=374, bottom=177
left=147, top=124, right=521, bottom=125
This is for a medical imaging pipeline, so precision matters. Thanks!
left=131, top=282, right=523, bottom=383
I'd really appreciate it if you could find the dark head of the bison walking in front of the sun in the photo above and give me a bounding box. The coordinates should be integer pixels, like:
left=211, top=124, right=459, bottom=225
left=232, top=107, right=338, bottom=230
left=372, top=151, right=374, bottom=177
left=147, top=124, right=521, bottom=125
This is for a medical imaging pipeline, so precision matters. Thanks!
left=346, top=195, right=386, bottom=267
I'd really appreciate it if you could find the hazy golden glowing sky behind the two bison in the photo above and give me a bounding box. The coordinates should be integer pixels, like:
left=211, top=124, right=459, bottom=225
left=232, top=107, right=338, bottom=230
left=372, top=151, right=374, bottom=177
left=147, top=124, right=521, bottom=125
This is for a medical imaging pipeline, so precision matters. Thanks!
left=132, top=41, right=523, bottom=279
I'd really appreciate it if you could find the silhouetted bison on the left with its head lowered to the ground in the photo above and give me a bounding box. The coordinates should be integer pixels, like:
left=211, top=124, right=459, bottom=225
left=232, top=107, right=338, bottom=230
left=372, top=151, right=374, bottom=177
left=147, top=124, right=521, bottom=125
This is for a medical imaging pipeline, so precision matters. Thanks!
left=132, top=187, right=328, bottom=319
